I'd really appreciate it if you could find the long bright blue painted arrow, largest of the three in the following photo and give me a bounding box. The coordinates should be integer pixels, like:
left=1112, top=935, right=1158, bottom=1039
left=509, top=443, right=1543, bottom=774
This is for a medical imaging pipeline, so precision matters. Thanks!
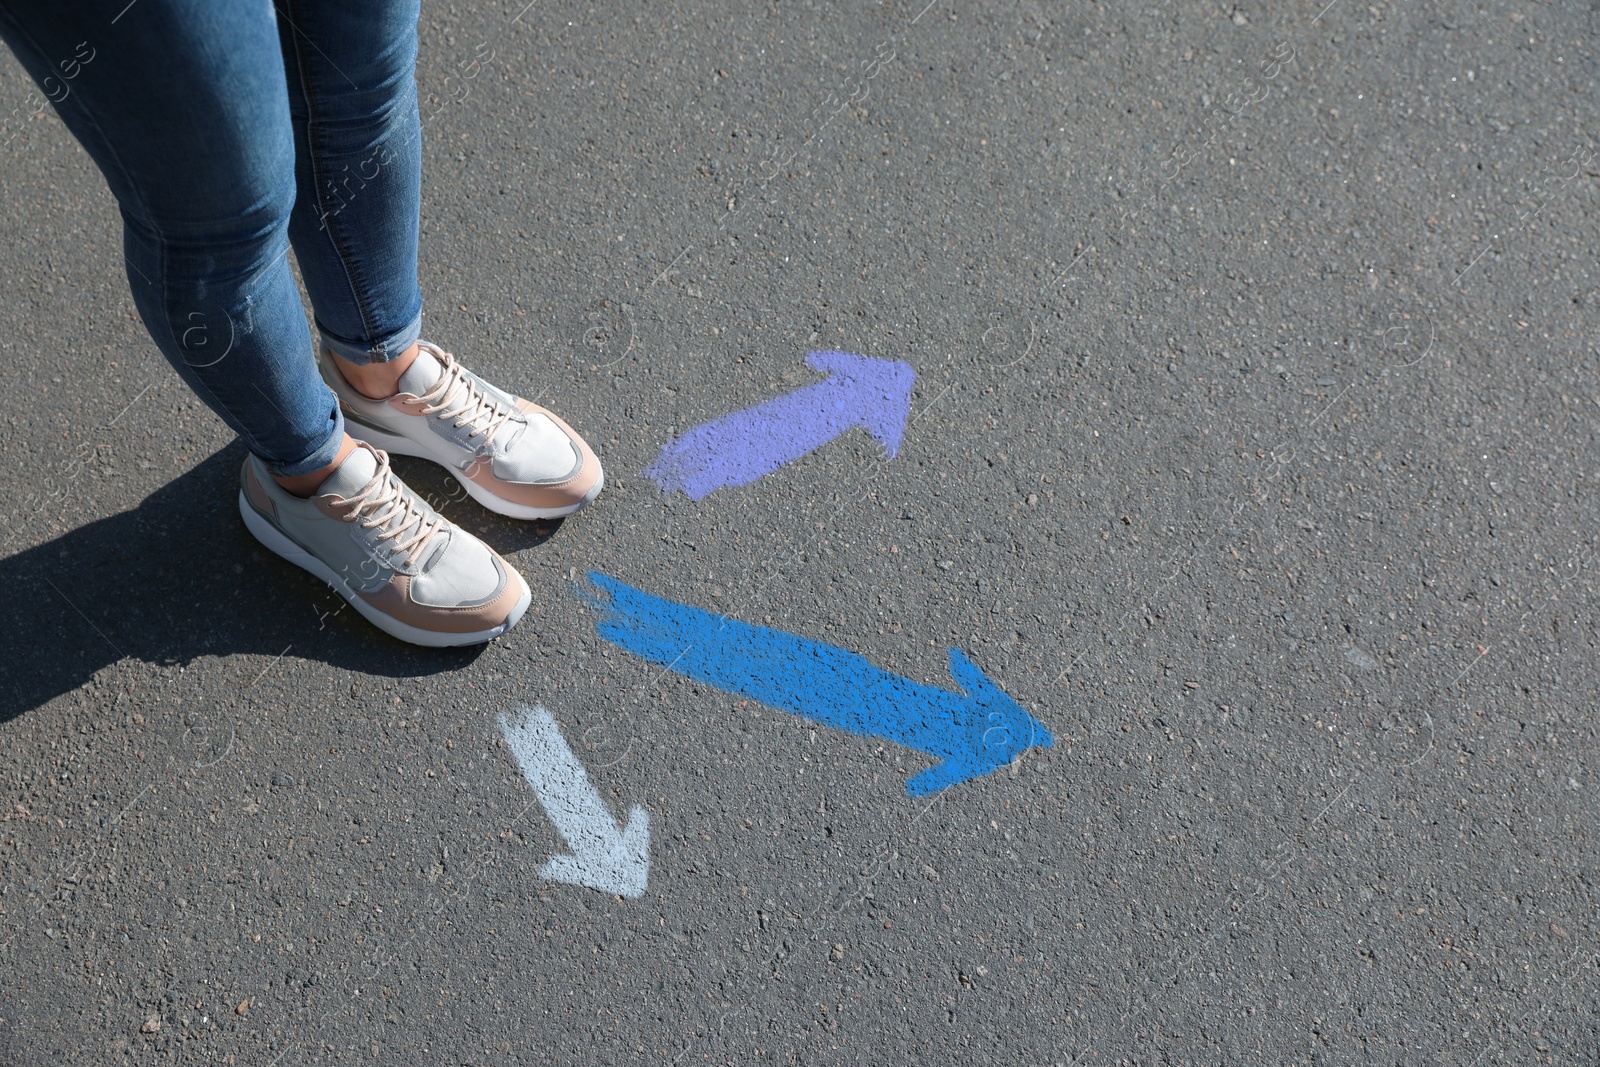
left=587, top=571, right=1054, bottom=797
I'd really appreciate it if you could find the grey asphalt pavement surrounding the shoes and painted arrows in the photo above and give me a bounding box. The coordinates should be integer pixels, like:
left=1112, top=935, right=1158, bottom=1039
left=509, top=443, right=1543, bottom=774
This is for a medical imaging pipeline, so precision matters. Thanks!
left=0, top=0, right=1600, bottom=1067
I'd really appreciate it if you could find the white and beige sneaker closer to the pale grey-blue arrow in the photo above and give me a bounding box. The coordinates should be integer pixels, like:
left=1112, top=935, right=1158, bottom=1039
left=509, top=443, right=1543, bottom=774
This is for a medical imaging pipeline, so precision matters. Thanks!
left=238, top=445, right=533, bottom=648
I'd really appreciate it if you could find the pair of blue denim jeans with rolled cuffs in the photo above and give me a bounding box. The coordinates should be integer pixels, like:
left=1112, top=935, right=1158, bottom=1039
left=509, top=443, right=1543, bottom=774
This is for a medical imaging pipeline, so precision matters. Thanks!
left=0, top=0, right=422, bottom=475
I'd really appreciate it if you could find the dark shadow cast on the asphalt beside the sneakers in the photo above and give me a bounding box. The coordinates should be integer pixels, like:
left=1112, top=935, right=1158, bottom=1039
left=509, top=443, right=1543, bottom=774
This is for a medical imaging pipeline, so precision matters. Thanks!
left=0, top=442, right=560, bottom=723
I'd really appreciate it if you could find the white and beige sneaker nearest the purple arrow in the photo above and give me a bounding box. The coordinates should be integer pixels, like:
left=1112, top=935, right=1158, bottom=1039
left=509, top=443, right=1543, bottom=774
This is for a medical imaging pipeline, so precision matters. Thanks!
left=317, top=341, right=605, bottom=518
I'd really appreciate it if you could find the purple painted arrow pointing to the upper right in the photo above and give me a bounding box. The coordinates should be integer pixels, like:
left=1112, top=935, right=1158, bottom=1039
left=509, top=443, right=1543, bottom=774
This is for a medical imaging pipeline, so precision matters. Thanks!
left=645, top=352, right=917, bottom=501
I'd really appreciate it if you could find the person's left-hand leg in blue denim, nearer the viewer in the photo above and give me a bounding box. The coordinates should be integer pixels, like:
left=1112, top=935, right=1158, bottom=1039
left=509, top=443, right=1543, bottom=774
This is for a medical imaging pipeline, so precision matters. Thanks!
left=0, top=0, right=344, bottom=477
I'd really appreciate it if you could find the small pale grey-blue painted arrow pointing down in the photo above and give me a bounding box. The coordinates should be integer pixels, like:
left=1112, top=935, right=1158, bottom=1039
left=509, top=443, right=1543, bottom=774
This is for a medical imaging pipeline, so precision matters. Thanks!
left=499, top=704, right=650, bottom=897
